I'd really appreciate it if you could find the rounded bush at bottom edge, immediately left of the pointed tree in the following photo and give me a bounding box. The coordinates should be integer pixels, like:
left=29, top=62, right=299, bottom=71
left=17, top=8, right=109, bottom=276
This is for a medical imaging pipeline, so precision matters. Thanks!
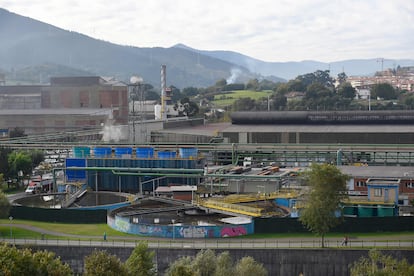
left=84, top=250, right=128, bottom=276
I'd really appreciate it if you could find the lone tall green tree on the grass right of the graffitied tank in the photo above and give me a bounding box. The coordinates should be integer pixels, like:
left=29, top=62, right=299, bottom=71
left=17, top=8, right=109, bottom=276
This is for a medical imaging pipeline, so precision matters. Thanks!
left=299, top=163, right=349, bottom=247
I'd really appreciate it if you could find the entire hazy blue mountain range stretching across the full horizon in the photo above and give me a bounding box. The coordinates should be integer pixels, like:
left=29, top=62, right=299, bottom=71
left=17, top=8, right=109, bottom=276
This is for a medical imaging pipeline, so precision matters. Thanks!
left=0, top=9, right=414, bottom=88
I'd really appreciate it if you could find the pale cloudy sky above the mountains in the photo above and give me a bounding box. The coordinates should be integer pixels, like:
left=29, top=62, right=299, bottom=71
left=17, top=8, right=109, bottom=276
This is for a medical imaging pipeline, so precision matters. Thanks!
left=0, top=0, right=414, bottom=62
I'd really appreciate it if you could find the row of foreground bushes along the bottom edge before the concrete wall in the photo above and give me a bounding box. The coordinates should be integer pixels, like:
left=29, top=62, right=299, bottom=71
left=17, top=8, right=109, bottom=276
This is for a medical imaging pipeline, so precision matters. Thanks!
left=0, top=242, right=414, bottom=276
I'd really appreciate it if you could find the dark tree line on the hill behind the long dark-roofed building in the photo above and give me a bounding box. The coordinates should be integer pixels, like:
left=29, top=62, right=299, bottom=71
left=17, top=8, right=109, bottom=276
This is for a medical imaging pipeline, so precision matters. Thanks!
left=148, top=70, right=414, bottom=117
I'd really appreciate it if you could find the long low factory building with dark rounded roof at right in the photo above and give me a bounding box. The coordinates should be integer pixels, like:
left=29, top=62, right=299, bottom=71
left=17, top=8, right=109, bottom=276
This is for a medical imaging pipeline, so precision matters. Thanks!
left=222, top=110, right=414, bottom=144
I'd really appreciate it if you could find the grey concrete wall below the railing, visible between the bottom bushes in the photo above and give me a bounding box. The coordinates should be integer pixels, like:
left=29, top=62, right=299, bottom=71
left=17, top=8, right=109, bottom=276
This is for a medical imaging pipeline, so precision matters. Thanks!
left=25, top=246, right=414, bottom=276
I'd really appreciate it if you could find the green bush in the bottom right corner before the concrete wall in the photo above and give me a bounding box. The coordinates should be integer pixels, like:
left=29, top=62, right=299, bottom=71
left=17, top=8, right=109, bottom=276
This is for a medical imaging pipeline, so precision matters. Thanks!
left=350, top=249, right=414, bottom=276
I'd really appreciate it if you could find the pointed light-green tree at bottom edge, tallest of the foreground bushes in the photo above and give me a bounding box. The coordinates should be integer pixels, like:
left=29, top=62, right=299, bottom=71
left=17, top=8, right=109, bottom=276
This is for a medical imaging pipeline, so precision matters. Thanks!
left=125, top=242, right=157, bottom=276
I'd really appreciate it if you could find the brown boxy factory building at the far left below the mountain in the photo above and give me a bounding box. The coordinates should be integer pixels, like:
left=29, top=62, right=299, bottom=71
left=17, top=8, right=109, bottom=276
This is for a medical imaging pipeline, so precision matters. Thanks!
left=0, top=76, right=128, bottom=134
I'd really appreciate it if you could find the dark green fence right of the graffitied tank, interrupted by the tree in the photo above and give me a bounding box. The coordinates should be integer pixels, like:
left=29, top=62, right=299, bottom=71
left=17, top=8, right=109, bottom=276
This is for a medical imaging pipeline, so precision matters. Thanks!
left=254, top=217, right=414, bottom=234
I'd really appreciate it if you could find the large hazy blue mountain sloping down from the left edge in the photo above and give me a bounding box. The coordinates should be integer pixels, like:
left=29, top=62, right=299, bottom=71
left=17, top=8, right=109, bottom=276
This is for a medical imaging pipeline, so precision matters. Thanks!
left=0, top=9, right=257, bottom=88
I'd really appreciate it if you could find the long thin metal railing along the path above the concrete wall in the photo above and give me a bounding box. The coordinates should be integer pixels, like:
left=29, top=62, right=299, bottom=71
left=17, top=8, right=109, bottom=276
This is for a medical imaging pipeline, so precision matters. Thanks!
left=0, top=238, right=414, bottom=250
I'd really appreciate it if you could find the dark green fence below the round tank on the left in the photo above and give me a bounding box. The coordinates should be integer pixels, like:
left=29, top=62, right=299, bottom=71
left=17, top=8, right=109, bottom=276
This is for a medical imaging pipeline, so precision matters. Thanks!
left=10, top=206, right=107, bottom=223
